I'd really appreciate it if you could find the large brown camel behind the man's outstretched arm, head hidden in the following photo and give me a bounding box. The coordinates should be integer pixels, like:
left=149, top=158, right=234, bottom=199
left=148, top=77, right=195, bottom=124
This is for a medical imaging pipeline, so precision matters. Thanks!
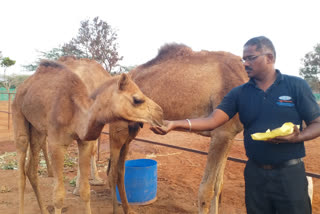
left=109, top=44, right=247, bottom=213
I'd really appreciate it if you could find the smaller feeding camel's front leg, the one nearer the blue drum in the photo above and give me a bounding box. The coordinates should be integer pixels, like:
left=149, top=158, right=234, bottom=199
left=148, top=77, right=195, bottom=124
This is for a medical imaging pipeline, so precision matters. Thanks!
left=78, top=141, right=95, bottom=214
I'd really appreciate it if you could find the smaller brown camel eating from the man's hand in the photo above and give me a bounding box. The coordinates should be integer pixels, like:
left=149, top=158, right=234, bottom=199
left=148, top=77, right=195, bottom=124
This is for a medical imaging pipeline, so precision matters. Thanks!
left=12, top=61, right=162, bottom=214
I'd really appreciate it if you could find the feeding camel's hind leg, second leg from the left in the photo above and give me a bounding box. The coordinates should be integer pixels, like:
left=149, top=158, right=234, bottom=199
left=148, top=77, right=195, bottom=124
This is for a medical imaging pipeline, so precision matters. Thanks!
left=27, top=128, right=48, bottom=213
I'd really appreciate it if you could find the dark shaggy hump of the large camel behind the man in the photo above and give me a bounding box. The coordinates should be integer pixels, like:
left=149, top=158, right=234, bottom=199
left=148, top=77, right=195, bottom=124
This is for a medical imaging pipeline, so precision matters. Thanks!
left=142, top=43, right=194, bottom=67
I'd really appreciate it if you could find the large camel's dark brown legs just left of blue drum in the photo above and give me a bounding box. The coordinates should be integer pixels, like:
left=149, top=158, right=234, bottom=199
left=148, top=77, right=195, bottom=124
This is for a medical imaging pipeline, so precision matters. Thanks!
left=109, top=122, right=139, bottom=214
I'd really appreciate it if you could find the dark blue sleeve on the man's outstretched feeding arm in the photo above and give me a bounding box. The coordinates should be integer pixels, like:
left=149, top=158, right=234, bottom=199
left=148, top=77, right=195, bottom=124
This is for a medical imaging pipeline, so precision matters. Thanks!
left=217, top=86, right=240, bottom=119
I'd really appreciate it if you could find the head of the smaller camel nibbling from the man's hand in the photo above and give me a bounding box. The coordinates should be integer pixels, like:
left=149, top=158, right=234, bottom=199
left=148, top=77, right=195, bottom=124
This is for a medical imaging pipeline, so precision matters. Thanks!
left=92, top=74, right=163, bottom=125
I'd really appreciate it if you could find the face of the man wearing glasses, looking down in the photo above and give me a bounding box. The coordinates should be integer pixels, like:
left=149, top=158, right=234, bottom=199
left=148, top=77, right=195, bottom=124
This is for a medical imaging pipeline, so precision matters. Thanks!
left=242, top=45, right=267, bottom=78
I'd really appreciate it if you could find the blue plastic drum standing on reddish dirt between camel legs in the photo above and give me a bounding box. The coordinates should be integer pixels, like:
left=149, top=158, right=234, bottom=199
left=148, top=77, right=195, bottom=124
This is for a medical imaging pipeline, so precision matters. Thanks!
left=116, top=159, right=157, bottom=205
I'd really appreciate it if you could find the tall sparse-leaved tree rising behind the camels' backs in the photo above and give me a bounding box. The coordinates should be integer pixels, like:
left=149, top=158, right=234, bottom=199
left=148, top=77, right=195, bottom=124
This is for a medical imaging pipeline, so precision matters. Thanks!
left=62, top=17, right=123, bottom=72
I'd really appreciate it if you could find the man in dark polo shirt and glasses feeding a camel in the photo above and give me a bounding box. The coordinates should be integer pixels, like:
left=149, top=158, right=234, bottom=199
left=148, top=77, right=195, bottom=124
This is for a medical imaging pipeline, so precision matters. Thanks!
left=151, top=36, right=320, bottom=214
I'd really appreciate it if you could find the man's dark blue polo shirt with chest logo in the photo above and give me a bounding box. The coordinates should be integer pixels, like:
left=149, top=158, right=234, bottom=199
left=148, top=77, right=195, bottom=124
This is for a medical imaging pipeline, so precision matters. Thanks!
left=217, top=70, right=320, bottom=164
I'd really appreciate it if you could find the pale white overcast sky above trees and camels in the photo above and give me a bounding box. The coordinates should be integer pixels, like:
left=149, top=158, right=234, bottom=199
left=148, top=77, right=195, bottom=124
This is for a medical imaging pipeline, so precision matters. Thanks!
left=0, top=0, right=320, bottom=76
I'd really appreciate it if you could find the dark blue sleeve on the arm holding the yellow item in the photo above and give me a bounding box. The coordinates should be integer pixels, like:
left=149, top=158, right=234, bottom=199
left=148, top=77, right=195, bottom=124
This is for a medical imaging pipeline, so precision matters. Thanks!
left=296, top=79, right=320, bottom=123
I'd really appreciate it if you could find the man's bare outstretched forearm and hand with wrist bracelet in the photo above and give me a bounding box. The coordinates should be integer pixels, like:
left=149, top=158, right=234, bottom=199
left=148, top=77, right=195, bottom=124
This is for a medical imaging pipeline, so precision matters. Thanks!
left=150, top=109, right=229, bottom=135
